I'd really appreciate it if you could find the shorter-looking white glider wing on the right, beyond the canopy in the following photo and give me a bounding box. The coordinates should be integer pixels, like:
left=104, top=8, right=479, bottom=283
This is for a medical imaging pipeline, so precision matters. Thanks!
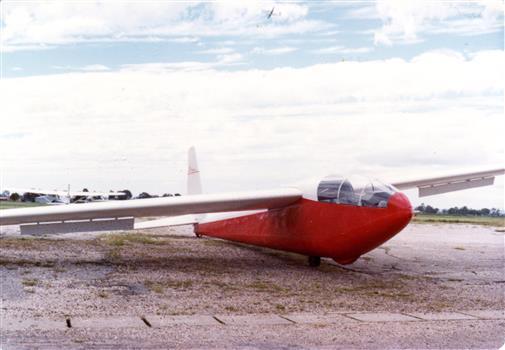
left=392, top=169, right=505, bottom=197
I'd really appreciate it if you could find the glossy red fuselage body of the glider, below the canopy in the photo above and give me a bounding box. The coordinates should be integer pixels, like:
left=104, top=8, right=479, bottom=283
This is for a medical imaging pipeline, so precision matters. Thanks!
left=196, top=193, right=412, bottom=264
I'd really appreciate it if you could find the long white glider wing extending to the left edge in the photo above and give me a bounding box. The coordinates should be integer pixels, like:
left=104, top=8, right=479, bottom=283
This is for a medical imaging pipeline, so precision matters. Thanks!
left=0, top=188, right=302, bottom=225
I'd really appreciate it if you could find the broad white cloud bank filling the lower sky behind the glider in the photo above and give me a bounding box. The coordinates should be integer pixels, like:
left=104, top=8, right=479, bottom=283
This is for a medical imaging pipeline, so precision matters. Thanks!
left=0, top=51, right=505, bottom=206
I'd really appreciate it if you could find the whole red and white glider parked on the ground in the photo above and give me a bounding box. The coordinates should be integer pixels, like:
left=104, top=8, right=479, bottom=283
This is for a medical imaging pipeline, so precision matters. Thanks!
left=0, top=148, right=505, bottom=265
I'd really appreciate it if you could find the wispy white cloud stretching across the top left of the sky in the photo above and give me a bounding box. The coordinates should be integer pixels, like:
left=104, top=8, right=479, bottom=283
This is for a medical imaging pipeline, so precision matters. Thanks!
left=1, top=1, right=327, bottom=52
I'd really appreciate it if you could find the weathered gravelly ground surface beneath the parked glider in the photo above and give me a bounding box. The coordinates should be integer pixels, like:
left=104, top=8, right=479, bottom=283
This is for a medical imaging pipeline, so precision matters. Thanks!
left=0, top=224, right=505, bottom=349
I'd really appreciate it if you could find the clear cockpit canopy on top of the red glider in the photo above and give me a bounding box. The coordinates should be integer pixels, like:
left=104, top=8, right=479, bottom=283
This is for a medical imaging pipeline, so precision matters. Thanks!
left=317, top=175, right=396, bottom=208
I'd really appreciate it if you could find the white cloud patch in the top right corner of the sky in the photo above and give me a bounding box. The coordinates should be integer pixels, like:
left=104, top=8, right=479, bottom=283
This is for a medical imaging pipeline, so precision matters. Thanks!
left=372, top=0, right=503, bottom=45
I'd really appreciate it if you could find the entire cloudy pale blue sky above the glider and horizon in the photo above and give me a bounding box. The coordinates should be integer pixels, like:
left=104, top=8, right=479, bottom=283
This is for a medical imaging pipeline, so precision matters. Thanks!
left=0, top=0, right=505, bottom=209
